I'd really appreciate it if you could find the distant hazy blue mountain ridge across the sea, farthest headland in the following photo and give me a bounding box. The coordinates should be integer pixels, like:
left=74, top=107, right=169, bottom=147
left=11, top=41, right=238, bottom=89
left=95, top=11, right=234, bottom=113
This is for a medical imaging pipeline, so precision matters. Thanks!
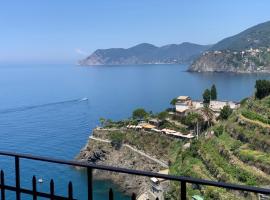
left=79, top=42, right=211, bottom=65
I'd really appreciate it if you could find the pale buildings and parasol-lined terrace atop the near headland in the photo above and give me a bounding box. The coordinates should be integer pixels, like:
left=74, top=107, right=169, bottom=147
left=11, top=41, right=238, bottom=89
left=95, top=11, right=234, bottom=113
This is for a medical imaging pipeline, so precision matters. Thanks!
left=126, top=90, right=240, bottom=139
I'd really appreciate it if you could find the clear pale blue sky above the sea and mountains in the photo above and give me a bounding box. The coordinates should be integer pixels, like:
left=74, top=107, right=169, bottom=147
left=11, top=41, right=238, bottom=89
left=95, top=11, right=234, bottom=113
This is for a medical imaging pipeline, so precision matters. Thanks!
left=0, top=0, right=270, bottom=63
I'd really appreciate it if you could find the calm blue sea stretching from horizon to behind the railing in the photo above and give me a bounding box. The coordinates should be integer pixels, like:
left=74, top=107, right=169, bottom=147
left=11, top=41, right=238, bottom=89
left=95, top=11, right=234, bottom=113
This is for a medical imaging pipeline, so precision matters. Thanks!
left=0, top=64, right=269, bottom=200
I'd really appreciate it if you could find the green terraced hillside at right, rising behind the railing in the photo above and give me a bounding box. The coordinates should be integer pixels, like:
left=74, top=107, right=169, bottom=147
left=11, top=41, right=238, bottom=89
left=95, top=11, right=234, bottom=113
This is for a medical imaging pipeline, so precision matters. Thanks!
left=170, top=96, right=270, bottom=199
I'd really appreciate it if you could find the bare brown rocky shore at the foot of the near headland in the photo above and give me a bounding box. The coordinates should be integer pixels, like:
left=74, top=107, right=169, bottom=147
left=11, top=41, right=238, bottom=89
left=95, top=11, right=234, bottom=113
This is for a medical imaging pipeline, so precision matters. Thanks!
left=76, top=129, right=165, bottom=194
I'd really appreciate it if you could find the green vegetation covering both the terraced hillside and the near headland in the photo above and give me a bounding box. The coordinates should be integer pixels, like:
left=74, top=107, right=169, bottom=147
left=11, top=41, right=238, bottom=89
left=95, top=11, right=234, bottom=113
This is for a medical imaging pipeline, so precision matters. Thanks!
left=99, top=82, right=270, bottom=200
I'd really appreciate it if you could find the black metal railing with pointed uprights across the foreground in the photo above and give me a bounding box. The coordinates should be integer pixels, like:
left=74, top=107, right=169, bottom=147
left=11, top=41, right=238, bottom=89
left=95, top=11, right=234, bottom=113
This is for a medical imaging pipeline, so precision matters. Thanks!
left=0, top=151, right=270, bottom=200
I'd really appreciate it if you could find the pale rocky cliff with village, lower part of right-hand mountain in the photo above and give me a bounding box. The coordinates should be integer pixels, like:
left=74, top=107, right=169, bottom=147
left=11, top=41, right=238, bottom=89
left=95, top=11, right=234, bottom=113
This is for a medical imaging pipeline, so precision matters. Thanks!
left=189, top=48, right=270, bottom=73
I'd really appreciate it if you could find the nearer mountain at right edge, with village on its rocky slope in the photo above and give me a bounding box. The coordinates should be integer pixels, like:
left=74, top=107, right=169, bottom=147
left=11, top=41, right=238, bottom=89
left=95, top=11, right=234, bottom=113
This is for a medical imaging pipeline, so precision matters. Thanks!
left=189, top=21, right=270, bottom=73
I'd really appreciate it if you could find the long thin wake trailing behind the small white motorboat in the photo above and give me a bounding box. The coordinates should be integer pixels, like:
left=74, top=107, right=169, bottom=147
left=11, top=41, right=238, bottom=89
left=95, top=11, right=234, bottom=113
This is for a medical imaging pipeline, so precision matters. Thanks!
left=0, top=97, right=88, bottom=114
